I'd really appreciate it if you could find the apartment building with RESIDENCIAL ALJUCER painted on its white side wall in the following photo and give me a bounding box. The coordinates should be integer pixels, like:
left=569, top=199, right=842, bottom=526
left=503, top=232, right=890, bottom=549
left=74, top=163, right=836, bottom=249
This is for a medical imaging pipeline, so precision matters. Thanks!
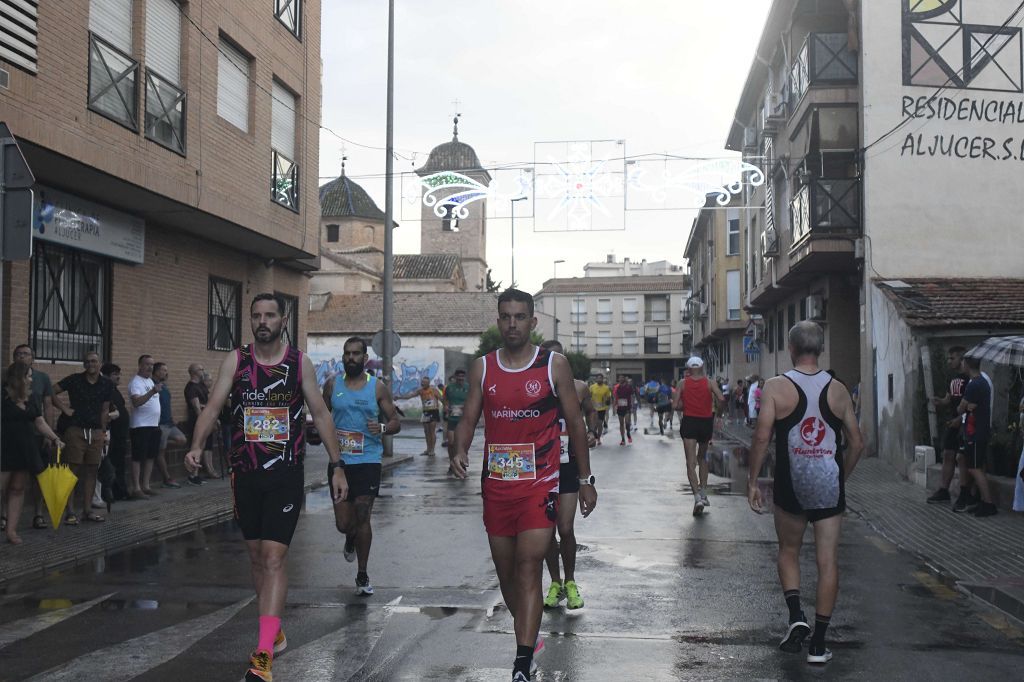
left=727, top=0, right=1024, bottom=472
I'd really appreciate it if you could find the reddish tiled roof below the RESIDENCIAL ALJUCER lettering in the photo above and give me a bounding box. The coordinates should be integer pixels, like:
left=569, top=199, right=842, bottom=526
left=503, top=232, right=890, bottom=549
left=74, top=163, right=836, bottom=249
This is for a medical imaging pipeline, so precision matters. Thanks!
left=874, top=278, right=1024, bottom=328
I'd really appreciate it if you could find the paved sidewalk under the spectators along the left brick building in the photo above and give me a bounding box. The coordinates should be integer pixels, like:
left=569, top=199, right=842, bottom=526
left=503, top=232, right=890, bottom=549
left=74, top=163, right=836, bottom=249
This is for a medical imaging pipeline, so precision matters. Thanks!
left=0, top=434, right=415, bottom=587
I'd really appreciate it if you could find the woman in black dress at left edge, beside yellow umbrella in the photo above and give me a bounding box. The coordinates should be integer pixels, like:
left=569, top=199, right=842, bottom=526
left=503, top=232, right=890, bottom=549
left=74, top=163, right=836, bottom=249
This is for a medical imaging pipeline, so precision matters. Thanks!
left=0, top=361, right=62, bottom=545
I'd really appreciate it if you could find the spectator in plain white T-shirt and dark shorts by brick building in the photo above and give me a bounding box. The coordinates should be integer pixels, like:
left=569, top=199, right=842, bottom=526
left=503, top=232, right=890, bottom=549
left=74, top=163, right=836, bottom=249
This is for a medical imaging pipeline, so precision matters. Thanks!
left=128, top=355, right=161, bottom=500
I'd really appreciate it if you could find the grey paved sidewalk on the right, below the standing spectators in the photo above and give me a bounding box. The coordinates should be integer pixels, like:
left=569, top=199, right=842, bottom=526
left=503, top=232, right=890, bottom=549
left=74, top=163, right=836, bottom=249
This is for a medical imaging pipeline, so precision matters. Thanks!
left=723, top=424, right=1024, bottom=621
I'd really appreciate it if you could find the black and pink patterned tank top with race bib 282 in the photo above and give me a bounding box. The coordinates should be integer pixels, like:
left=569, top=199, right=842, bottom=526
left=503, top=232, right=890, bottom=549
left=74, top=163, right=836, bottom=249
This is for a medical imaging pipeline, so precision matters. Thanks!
left=229, top=345, right=305, bottom=472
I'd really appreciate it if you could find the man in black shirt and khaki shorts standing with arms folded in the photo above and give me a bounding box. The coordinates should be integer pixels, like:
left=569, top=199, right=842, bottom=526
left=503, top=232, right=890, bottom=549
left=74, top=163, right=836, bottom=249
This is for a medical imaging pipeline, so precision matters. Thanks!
left=53, top=350, right=114, bottom=525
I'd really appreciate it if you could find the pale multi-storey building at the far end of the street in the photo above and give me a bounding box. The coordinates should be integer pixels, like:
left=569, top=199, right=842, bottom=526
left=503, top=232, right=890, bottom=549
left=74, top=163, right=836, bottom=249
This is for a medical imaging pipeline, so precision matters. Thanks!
left=534, top=266, right=691, bottom=381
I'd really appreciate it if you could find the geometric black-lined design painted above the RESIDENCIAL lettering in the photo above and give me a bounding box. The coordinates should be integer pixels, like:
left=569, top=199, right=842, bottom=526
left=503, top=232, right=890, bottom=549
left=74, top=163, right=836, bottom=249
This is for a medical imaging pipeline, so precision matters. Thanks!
left=903, top=0, right=1024, bottom=92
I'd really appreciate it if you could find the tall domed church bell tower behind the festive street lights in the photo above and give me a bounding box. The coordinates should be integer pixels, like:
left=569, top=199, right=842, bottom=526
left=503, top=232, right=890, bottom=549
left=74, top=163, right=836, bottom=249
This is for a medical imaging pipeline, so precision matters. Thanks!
left=416, top=116, right=490, bottom=291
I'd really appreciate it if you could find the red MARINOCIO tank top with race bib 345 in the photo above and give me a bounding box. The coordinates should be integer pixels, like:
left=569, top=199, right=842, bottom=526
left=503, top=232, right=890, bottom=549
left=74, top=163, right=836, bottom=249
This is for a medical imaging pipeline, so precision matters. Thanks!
left=480, top=347, right=561, bottom=502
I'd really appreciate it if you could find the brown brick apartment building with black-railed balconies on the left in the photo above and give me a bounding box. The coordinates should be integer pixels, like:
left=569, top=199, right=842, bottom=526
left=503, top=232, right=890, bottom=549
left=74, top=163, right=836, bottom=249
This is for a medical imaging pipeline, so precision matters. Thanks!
left=0, top=0, right=321, bottom=419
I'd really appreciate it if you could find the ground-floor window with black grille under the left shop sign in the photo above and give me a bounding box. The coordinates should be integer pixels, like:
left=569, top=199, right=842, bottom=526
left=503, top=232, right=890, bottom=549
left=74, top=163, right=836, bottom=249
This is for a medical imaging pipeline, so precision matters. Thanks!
left=30, top=240, right=111, bottom=361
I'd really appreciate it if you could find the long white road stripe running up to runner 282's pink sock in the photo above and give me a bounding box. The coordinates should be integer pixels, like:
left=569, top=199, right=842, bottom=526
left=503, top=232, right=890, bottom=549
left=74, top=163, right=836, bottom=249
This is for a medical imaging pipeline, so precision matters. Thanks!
left=30, top=595, right=253, bottom=682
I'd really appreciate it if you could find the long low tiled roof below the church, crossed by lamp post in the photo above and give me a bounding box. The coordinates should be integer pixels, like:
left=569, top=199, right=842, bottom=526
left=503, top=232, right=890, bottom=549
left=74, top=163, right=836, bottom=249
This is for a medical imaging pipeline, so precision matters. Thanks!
left=308, top=292, right=498, bottom=335
